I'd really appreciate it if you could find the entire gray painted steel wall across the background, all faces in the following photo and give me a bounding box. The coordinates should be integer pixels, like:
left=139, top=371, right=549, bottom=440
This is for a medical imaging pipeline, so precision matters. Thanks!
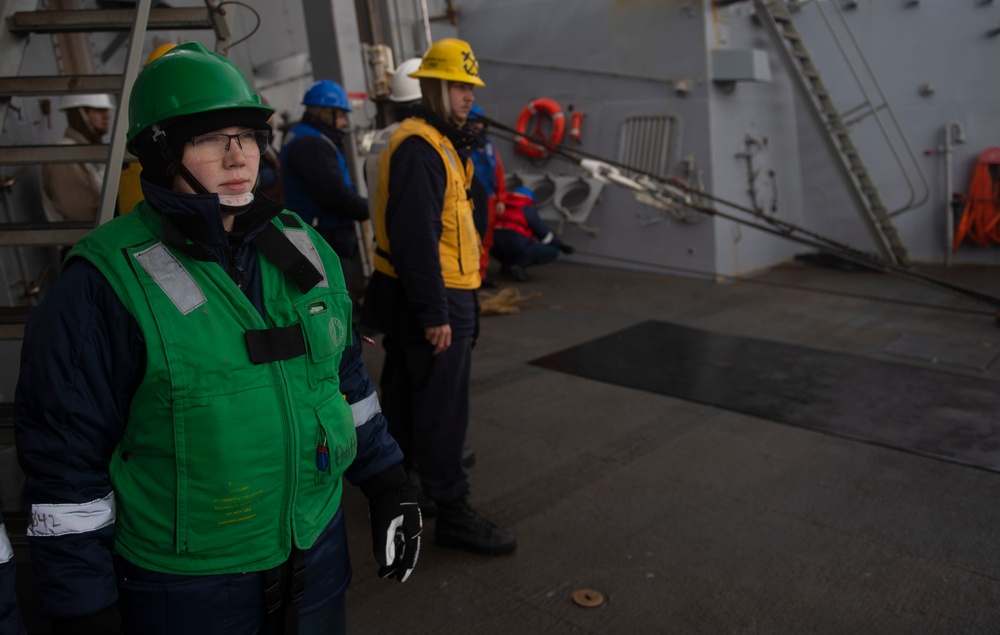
left=459, top=0, right=1000, bottom=274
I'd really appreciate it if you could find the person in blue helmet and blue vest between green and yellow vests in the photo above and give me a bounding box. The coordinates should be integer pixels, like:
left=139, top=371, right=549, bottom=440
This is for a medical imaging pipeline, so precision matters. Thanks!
left=279, top=79, right=368, bottom=300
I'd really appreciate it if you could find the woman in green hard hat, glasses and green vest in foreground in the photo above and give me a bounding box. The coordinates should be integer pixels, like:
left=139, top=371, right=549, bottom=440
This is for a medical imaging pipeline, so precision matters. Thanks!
left=15, top=43, right=421, bottom=635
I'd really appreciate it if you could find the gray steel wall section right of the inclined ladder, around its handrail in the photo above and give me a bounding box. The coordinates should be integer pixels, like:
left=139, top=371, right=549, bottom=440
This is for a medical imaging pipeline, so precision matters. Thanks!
left=788, top=0, right=1000, bottom=264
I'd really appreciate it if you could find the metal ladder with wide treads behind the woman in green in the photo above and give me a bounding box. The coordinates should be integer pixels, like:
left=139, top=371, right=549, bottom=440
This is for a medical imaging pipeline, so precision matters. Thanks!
left=0, top=0, right=230, bottom=632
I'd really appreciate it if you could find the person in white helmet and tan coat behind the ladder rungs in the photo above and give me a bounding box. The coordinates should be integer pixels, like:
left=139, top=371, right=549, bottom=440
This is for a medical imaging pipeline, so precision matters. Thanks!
left=41, top=94, right=114, bottom=222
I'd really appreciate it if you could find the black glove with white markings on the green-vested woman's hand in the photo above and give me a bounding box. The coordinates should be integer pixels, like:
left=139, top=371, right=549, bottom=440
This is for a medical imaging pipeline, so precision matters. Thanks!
left=361, top=465, right=423, bottom=582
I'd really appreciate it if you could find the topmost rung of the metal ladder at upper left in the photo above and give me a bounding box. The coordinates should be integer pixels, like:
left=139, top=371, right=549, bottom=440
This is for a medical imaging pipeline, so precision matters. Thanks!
left=7, top=7, right=213, bottom=33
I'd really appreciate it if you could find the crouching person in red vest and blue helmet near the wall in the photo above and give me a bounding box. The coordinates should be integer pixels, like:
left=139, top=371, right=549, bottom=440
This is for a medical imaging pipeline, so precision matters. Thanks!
left=493, top=187, right=574, bottom=282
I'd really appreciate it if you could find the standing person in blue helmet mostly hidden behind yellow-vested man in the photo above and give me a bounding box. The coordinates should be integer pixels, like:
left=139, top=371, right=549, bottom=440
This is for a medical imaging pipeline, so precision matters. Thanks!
left=466, top=104, right=507, bottom=287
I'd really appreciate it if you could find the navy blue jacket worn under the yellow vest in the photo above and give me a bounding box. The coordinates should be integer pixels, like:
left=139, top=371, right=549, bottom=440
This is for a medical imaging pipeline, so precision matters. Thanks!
left=361, top=106, right=476, bottom=340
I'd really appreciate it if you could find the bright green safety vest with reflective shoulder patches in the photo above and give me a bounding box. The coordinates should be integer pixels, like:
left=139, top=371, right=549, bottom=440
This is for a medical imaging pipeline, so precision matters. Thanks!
left=71, top=201, right=357, bottom=574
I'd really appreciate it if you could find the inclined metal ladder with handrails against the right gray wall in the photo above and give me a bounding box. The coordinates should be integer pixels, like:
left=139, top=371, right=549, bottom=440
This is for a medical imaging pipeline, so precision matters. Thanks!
left=753, top=0, right=929, bottom=266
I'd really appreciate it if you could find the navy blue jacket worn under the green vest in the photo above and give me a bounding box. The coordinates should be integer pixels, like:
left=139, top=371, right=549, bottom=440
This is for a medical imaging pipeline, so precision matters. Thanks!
left=14, top=181, right=402, bottom=619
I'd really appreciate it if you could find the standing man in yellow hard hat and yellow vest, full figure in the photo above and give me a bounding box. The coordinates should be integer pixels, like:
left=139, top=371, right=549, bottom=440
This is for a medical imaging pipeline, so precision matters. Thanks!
left=362, top=38, right=517, bottom=555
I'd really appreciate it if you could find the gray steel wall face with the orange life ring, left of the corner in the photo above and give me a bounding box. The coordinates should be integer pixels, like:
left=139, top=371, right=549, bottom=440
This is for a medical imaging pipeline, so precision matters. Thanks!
left=459, top=0, right=715, bottom=278
